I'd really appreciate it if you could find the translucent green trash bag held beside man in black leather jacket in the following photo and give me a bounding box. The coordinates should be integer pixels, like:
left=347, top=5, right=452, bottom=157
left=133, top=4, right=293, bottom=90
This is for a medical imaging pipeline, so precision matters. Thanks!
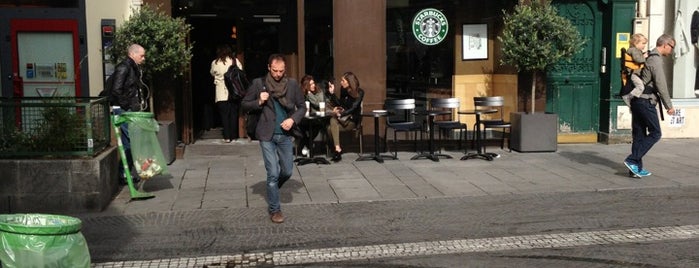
left=120, top=112, right=168, bottom=180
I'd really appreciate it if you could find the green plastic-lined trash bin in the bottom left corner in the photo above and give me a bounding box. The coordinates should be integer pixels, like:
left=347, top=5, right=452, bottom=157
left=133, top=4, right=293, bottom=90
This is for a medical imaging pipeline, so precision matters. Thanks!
left=0, top=214, right=91, bottom=268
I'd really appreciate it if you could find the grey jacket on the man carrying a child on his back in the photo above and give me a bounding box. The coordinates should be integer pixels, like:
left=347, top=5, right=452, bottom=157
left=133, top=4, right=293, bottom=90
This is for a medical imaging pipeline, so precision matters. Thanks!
left=642, top=48, right=672, bottom=109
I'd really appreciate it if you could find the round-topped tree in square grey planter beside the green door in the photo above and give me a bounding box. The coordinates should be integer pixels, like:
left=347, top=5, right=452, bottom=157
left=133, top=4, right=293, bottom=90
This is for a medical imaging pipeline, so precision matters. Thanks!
left=498, top=0, right=584, bottom=152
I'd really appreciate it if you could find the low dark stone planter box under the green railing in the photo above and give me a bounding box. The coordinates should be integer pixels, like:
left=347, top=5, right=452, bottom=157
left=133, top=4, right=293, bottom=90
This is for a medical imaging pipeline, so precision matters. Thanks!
left=0, top=146, right=119, bottom=213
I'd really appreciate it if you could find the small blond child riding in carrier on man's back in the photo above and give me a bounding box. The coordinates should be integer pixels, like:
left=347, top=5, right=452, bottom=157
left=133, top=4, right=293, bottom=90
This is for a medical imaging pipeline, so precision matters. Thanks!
left=621, top=34, right=648, bottom=107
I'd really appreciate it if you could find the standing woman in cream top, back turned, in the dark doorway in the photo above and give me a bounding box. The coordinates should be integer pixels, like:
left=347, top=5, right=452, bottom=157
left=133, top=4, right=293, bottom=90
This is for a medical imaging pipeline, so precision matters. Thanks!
left=209, top=45, right=243, bottom=143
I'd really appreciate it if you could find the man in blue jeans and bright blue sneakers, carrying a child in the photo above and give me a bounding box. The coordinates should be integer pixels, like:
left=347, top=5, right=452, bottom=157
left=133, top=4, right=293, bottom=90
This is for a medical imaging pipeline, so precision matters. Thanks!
left=624, top=34, right=675, bottom=178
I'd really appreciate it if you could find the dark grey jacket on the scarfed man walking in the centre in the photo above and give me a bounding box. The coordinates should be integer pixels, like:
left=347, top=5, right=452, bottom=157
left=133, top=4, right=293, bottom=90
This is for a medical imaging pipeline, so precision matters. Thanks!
left=241, top=76, right=306, bottom=141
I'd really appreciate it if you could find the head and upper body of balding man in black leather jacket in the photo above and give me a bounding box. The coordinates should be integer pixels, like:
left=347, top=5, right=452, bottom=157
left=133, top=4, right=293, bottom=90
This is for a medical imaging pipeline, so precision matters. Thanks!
left=109, top=44, right=147, bottom=112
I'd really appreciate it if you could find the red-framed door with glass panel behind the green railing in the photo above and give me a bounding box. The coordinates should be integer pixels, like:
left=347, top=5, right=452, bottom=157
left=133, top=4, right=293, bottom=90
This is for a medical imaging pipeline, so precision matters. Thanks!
left=10, top=19, right=81, bottom=97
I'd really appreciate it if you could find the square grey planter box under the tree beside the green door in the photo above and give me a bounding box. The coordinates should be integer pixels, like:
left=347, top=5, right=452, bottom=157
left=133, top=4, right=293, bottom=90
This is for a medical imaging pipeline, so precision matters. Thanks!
left=510, top=113, right=558, bottom=152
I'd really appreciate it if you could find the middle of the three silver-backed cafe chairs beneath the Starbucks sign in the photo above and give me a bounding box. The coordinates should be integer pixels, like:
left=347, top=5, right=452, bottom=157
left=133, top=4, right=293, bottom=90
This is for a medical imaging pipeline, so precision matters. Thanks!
left=429, top=98, right=468, bottom=153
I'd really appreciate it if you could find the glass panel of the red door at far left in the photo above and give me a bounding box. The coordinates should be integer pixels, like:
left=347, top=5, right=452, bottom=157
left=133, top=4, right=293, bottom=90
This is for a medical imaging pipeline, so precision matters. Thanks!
left=17, top=32, right=75, bottom=97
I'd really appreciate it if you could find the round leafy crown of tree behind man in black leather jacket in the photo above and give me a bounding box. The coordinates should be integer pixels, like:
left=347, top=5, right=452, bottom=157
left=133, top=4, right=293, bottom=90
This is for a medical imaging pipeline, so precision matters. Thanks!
left=107, top=5, right=192, bottom=79
